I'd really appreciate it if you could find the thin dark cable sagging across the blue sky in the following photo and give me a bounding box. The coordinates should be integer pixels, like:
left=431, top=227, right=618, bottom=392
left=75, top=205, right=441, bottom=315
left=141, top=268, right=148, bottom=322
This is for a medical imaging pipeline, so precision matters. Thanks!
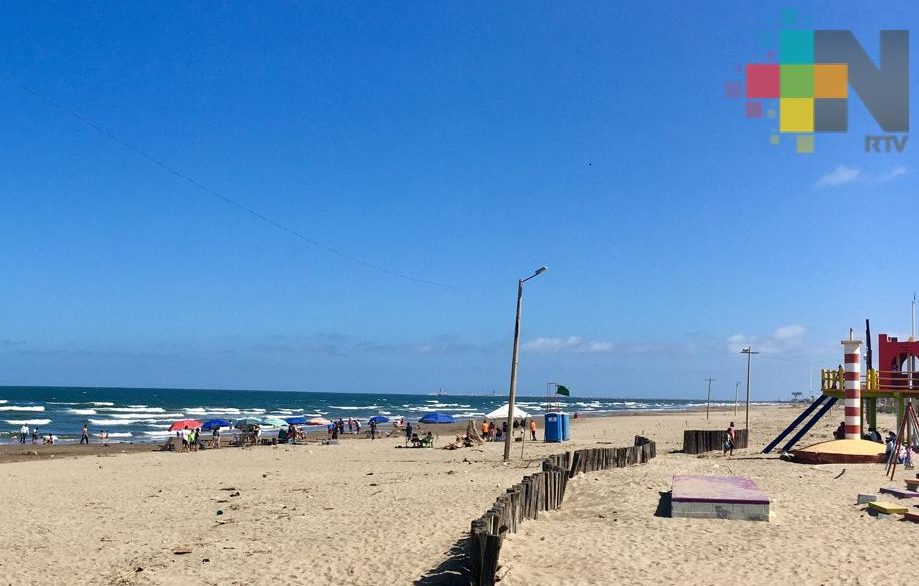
left=0, top=71, right=460, bottom=289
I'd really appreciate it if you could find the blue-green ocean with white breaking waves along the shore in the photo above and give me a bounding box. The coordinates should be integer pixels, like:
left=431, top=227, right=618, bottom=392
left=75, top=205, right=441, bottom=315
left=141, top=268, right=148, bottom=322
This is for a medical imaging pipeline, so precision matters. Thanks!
left=0, top=387, right=726, bottom=443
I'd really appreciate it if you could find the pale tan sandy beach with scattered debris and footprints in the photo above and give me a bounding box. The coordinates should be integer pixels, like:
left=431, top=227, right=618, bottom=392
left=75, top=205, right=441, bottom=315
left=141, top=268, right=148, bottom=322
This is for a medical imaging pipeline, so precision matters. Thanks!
left=0, top=406, right=914, bottom=585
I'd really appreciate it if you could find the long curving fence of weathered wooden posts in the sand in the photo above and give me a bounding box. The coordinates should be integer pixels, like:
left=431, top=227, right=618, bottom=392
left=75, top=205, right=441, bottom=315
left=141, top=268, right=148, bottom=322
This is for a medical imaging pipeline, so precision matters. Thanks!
left=469, top=435, right=657, bottom=586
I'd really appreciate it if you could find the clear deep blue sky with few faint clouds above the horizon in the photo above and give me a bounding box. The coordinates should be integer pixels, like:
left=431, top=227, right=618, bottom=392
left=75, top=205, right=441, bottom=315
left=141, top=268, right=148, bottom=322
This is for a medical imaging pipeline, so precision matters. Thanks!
left=0, top=2, right=919, bottom=399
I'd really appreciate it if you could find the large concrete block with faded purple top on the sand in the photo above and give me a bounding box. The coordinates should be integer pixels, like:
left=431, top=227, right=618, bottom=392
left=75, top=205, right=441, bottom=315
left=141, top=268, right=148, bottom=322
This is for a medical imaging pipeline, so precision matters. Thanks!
left=670, top=475, right=769, bottom=521
